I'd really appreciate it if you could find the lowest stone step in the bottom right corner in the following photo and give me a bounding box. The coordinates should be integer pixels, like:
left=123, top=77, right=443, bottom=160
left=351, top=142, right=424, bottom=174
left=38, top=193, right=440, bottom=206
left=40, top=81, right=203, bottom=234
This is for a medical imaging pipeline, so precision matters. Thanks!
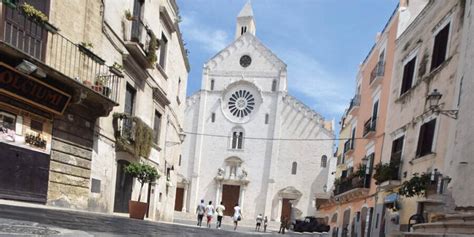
left=413, top=222, right=474, bottom=235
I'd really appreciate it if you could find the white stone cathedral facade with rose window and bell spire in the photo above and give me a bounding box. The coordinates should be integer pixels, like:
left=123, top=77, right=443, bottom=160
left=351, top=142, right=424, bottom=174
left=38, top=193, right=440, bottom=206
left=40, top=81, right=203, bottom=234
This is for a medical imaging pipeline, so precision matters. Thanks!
left=175, top=3, right=334, bottom=221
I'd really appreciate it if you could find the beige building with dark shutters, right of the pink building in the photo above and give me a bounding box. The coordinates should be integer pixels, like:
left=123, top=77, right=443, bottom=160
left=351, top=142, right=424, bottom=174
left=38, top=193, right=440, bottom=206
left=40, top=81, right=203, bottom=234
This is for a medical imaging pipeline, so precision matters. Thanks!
left=381, top=1, right=464, bottom=234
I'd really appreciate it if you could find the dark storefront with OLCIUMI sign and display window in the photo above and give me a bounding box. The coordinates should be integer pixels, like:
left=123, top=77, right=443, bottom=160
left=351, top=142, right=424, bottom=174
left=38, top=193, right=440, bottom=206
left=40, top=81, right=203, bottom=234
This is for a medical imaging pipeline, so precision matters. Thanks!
left=0, top=62, right=71, bottom=203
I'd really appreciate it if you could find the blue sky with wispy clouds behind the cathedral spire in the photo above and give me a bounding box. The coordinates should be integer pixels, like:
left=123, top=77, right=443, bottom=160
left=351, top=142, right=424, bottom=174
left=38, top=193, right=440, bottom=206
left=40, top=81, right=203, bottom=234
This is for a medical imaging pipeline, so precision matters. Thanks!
left=178, top=0, right=399, bottom=122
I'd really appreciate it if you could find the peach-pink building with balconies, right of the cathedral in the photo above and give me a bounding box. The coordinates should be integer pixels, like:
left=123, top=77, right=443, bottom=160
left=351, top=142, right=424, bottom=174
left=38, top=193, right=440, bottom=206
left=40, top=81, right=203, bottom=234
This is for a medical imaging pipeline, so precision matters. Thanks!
left=320, top=4, right=398, bottom=236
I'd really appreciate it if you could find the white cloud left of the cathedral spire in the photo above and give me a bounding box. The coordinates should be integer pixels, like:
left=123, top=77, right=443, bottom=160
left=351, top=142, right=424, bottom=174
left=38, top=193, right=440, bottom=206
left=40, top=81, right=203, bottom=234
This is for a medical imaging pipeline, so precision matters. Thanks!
left=181, top=15, right=229, bottom=53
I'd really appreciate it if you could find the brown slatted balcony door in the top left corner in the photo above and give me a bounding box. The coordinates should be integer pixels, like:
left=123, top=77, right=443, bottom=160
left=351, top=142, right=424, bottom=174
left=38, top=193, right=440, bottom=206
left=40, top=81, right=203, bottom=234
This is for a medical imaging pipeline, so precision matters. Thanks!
left=0, top=0, right=50, bottom=61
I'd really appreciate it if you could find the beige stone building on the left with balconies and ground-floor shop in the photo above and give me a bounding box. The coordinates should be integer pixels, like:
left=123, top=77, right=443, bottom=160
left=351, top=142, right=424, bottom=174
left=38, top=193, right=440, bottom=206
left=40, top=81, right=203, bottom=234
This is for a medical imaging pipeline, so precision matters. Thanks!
left=0, top=0, right=189, bottom=220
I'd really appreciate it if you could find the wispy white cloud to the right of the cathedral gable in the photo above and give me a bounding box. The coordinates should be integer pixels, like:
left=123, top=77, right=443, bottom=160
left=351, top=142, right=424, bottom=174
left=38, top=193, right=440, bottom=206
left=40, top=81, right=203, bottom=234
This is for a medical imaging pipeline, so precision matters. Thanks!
left=281, top=50, right=353, bottom=119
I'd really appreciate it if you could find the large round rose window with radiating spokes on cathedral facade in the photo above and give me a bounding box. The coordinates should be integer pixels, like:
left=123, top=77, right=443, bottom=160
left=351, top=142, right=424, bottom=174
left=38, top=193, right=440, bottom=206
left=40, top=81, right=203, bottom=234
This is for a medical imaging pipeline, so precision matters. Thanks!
left=228, top=90, right=255, bottom=118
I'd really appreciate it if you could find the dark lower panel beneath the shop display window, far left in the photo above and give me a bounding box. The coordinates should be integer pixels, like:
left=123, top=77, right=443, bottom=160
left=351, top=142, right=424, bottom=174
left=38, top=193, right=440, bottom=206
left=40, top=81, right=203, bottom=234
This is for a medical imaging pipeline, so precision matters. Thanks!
left=0, top=142, right=49, bottom=203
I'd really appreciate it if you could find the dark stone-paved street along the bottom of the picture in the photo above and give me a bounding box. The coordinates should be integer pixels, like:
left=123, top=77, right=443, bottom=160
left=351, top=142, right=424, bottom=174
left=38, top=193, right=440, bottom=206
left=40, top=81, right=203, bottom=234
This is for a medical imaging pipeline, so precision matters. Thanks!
left=0, top=205, right=328, bottom=237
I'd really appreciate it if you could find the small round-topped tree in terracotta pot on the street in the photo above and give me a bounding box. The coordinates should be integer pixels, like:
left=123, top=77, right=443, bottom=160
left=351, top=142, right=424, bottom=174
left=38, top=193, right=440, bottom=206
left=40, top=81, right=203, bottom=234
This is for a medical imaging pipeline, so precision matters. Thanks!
left=125, top=162, right=160, bottom=220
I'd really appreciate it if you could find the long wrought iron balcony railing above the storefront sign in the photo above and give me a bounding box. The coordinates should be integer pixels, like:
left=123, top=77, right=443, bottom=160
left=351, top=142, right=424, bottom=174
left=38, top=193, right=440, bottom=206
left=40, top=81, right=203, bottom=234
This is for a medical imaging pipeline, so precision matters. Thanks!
left=0, top=6, right=120, bottom=102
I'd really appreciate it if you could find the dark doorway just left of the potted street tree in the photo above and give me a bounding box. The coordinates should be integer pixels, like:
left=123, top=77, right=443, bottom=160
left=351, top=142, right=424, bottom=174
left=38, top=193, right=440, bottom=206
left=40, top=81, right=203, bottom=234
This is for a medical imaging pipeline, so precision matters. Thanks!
left=114, top=160, right=133, bottom=213
